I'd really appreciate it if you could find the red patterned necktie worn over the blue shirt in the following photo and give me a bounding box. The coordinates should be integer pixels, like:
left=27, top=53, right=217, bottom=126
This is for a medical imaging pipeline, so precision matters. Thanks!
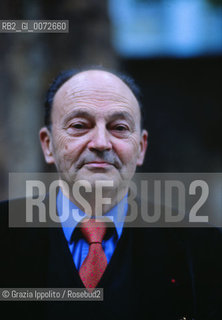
left=79, top=219, right=107, bottom=291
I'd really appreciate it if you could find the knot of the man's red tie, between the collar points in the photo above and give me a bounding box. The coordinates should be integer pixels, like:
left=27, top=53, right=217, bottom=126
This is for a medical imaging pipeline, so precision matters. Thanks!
left=80, top=219, right=106, bottom=244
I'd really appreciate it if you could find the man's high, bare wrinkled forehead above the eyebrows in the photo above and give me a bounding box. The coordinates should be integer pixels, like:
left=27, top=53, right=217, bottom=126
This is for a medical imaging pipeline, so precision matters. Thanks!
left=52, top=70, right=140, bottom=119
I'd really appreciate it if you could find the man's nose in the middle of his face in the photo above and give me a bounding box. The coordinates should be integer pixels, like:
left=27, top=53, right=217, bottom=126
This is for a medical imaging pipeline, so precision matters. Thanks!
left=88, top=126, right=112, bottom=151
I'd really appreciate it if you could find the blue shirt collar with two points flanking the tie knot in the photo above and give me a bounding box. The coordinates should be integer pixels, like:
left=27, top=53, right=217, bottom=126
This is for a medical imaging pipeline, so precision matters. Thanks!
left=56, top=189, right=128, bottom=242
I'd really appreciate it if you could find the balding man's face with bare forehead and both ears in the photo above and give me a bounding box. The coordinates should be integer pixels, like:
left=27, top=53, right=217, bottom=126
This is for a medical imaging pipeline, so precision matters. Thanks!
left=40, top=70, right=147, bottom=190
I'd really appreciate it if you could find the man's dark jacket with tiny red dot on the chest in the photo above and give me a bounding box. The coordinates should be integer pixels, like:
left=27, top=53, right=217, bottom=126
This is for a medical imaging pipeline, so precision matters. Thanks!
left=0, top=200, right=222, bottom=320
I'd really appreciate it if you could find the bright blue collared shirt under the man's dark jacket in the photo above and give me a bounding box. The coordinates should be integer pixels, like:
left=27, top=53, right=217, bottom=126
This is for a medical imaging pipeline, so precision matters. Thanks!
left=57, top=189, right=128, bottom=270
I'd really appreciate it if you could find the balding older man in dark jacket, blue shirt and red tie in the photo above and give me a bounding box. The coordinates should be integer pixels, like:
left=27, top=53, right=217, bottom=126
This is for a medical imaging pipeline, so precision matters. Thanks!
left=1, top=69, right=222, bottom=320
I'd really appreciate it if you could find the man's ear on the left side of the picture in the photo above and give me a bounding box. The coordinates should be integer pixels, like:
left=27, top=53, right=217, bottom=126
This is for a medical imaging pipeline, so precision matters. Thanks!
left=39, top=127, right=55, bottom=164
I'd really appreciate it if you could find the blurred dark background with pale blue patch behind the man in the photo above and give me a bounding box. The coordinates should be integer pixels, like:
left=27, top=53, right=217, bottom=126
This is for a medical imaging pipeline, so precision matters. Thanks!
left=0, top=0, right=222, bottom=199
